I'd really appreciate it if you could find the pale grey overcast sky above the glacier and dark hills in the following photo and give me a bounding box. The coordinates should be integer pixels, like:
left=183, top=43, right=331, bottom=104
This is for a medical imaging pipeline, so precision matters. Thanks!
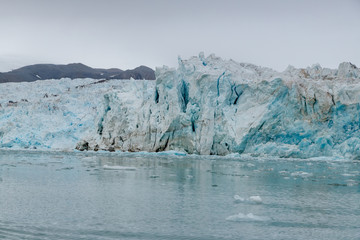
left=0, top=0, right=360, bottom=71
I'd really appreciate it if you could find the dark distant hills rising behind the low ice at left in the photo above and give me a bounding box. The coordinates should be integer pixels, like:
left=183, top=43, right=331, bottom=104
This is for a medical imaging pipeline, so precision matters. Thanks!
left=0, top=63, right=155, bottom=83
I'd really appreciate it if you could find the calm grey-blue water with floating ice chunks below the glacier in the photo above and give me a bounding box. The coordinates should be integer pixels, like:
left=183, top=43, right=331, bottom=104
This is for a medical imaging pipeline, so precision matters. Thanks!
left=0, top=151, right=360, bottom=240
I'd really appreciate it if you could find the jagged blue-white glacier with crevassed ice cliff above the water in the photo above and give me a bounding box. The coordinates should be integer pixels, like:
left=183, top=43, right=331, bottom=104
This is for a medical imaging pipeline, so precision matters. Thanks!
left=0, top=53, right=360, bottom=159
